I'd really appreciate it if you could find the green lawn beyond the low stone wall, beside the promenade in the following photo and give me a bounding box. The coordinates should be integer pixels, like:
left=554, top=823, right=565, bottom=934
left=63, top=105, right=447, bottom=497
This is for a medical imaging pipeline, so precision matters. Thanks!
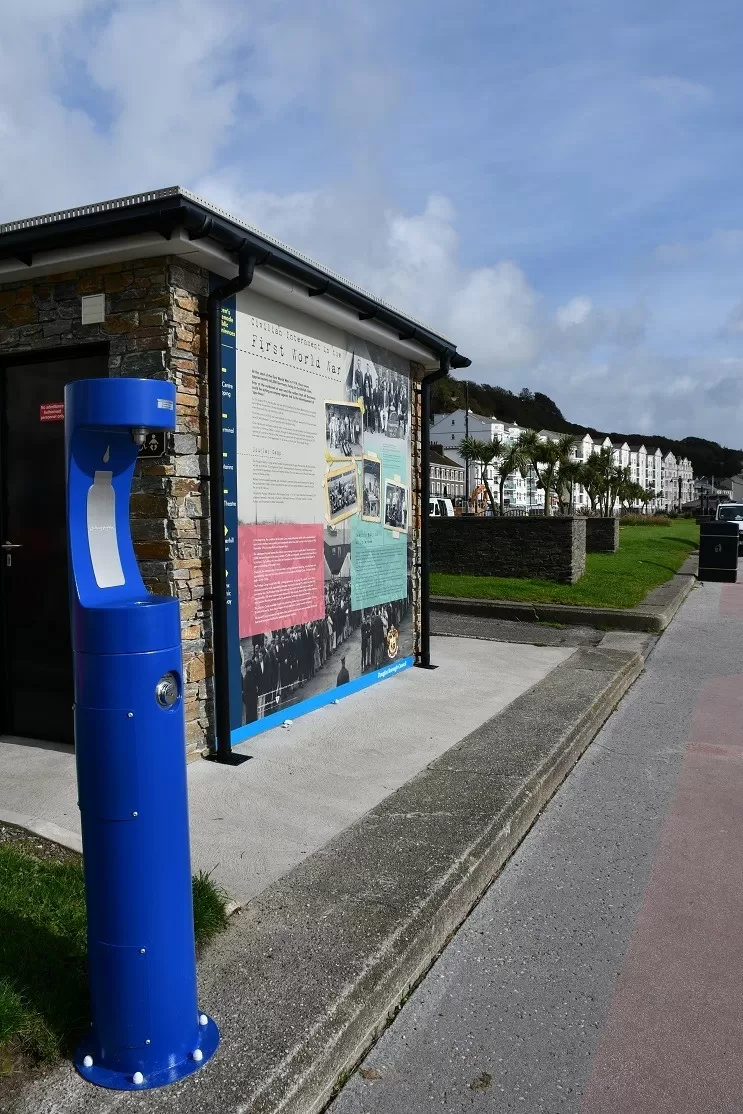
left=431, top=518, right=700, bottom=607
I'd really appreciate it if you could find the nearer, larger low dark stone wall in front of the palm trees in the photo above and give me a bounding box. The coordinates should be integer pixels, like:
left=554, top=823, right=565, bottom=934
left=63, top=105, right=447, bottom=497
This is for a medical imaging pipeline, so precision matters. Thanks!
left=430, top=515, right=586, bottom=584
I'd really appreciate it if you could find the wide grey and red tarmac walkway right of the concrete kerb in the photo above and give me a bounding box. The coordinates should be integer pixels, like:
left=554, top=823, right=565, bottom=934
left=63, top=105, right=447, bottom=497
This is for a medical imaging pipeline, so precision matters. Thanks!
left=332, top=584, right=743, bottom=1114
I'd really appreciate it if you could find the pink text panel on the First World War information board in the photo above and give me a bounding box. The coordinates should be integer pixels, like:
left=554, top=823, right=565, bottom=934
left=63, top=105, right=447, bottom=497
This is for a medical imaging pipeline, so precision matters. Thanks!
left=237, top=524, right=325, bottom=638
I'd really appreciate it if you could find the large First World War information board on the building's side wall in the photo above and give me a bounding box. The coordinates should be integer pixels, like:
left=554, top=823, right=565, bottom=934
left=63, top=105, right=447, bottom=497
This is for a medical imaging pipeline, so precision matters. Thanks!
left=222, top=291, right=413, bottom=744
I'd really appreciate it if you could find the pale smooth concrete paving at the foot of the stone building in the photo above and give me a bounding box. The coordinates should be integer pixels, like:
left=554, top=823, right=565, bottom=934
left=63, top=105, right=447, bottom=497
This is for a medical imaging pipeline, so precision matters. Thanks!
left=0, top=638, right=574, bottom=902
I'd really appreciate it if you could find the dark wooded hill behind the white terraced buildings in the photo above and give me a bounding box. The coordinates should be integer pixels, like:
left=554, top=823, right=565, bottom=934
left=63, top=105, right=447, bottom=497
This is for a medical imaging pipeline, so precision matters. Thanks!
left=431, top=375, right=743, bottom=479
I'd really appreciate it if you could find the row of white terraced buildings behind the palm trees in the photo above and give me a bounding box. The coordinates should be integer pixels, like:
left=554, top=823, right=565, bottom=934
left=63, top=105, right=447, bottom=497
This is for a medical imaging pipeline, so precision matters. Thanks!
left=429, top=410, right=694, bottom=512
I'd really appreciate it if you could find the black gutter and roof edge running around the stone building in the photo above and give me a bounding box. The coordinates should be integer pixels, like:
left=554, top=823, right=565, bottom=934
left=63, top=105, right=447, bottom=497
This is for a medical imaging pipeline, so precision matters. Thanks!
left=0, top=193, right=469, bottom=368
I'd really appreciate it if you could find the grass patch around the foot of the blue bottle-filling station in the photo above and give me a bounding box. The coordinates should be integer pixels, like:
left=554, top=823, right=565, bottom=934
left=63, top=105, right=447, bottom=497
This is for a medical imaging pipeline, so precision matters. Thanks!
left=0, top=840, right=227, bottom=1076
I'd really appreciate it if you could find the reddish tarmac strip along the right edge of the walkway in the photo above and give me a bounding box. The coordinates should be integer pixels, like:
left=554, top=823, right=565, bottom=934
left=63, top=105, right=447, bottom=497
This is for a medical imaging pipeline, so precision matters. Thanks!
left=581, top=584, right=743, bottom=1114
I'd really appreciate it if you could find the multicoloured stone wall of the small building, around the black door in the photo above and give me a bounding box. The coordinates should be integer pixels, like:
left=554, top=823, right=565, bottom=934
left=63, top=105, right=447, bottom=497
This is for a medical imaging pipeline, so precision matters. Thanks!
left=0, top=256, right=212, bottom=758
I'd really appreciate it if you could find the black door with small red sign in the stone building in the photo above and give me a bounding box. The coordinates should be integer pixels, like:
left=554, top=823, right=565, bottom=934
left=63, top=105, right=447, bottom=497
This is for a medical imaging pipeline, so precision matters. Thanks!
left=0, top=351, right=108, bottom=743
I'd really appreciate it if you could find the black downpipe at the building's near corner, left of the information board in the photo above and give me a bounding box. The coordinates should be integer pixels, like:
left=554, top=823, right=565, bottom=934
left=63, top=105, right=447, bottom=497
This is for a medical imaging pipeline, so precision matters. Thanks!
left=207, top=255, right=257, bottom=765
